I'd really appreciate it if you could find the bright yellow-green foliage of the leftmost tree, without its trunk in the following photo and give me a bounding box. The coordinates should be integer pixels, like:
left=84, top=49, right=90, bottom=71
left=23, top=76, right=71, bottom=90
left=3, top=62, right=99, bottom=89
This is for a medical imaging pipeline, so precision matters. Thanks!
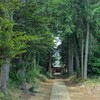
left=0, top=0, right=27, bottom=58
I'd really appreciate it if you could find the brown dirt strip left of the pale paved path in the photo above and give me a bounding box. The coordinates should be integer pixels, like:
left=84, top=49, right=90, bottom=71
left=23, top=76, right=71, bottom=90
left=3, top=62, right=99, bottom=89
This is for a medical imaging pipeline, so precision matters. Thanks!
left=24, top=79, right=53, bottom=100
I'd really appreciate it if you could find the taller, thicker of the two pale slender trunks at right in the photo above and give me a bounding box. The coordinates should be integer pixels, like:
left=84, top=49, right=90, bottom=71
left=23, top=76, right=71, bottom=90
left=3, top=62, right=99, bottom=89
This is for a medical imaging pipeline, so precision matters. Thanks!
left=84, top=22, right=89, bottom=79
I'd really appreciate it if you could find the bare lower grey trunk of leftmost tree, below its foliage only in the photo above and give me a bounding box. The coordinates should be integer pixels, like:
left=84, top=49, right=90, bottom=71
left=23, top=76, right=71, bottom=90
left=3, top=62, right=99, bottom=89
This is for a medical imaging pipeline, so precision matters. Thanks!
left=0, top=58, right=10, bottom=91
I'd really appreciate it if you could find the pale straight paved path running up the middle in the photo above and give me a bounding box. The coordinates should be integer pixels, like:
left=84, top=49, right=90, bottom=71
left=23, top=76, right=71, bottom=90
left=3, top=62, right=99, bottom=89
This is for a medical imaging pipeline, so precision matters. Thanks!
left=50, top=79, right=71, bottom=100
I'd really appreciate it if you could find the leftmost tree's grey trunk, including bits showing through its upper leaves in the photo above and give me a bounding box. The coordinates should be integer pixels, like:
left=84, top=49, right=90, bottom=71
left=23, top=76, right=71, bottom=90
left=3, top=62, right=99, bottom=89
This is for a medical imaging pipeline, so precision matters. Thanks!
left=0, top=0, right=13, bottom=91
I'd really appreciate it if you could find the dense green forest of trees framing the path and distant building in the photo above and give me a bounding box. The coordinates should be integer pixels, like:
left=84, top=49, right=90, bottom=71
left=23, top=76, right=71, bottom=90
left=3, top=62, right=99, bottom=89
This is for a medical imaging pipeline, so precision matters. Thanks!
left=0, top=0, right=100, bottom=100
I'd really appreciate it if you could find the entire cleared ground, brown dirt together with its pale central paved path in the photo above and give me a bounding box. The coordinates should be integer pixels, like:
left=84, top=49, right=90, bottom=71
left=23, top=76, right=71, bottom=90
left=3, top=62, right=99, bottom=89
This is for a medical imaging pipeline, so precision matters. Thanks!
left=24, top=76, right=100, bottom=100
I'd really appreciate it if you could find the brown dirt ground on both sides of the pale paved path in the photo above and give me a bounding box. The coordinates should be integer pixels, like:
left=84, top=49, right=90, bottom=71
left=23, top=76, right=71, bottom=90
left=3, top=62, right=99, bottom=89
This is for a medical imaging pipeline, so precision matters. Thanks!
left=24, top=76, right=100, bottom=100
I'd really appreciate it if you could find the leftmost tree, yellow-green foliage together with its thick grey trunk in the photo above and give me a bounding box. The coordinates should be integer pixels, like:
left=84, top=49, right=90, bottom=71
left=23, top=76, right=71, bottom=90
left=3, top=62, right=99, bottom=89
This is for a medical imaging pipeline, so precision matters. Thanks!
left=0, top=1, right=28, bottom=91
